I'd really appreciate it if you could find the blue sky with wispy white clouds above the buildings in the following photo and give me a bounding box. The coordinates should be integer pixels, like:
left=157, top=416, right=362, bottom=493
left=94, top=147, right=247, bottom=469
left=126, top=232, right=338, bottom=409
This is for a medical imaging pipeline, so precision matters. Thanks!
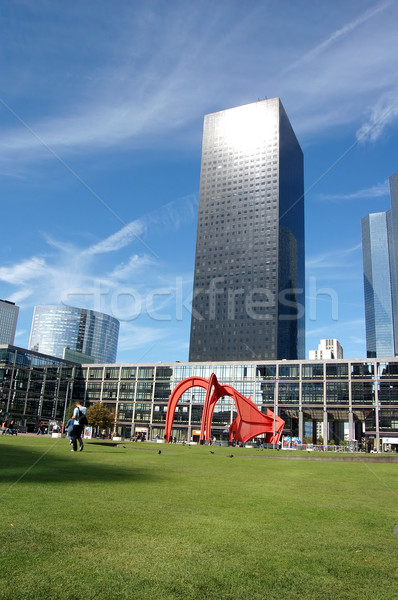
left=0, top=0, right=398, bottom=362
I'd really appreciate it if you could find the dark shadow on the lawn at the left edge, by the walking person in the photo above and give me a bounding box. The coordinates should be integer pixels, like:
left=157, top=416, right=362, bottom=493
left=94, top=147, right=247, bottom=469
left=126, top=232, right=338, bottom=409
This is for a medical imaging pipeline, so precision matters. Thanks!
left=0, top=438, right=156, bottom=484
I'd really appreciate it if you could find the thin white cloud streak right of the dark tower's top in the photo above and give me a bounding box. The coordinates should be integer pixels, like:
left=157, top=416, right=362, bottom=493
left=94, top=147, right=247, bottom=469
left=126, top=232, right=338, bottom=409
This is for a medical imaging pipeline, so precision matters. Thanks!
left=274, top=2, right=398, bottom=141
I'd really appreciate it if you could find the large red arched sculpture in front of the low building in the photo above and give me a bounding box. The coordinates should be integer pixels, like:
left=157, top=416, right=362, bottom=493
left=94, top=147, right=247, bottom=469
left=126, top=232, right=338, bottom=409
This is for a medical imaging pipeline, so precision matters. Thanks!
left=165, top=373, right=285, bottom=444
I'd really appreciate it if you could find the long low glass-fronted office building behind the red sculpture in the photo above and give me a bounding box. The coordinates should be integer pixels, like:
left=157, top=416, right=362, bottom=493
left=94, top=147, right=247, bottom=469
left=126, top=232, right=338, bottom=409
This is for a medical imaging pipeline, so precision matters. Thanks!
left=0, top=346, right=398, bottom=448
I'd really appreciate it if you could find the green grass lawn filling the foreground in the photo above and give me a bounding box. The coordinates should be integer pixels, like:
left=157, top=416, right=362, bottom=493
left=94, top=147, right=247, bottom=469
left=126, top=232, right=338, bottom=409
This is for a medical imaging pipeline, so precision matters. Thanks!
left=0, top=436, right=398, bottom=600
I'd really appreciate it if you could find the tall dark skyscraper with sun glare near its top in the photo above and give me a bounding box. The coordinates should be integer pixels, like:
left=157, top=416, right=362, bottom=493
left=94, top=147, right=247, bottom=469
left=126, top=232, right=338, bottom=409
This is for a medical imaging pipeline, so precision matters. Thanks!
left=189, top=98, right=305, bottom=361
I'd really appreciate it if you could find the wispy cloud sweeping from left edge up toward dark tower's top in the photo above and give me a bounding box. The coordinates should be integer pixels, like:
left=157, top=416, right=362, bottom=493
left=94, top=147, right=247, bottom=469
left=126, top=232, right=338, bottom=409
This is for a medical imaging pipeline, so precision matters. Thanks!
left=0, top=5, right=239, bottom=159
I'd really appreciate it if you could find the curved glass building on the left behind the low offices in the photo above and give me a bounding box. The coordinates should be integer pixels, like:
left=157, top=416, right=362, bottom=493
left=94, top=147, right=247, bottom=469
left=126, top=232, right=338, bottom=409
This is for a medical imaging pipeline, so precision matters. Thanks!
left=29, top=305, right=120, bottom=363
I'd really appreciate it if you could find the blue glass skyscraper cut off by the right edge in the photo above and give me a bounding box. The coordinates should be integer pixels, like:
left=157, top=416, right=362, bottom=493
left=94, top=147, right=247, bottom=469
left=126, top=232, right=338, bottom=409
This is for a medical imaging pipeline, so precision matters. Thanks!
left=361, top=172, right=398, bottom=358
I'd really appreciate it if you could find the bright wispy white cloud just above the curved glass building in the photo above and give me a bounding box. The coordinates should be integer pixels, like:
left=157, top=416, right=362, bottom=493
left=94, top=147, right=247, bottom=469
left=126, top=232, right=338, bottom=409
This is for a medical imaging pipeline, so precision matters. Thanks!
left=0, top=195, right=197, bottom=321
